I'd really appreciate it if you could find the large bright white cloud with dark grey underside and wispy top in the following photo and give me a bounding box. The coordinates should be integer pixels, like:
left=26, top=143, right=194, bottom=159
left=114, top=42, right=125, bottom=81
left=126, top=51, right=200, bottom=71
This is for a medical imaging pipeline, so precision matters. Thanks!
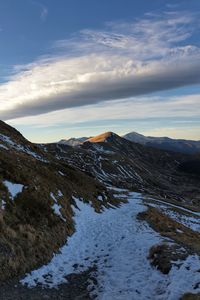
left=0, top=12, right=200, bottom=120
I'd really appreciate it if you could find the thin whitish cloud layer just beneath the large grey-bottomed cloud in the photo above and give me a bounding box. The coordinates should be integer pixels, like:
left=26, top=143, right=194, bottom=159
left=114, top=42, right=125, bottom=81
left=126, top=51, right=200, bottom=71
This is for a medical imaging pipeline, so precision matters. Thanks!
left=7, top=94, right=200, bottom=128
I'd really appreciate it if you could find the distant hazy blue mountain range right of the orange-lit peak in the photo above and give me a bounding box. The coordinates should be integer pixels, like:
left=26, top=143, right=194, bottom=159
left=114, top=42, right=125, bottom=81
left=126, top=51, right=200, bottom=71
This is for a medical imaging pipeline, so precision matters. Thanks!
left=123, top=132, right=200, bottom=154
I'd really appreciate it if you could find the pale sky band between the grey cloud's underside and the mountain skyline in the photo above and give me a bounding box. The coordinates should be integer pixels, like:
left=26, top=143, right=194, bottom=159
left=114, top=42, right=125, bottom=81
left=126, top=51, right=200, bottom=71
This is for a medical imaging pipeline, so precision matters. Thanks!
left=8, top=94, right=200, bottom=143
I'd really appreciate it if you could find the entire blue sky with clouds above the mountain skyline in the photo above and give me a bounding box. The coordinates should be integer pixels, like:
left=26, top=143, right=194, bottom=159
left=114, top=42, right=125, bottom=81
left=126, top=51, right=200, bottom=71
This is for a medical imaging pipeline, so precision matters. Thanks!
left=0, top=0, right=200, bottom=142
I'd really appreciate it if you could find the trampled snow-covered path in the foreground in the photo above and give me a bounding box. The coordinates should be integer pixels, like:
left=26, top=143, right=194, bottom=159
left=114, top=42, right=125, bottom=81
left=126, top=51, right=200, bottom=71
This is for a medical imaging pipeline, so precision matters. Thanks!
left=22, top=193, right=200, bottom=300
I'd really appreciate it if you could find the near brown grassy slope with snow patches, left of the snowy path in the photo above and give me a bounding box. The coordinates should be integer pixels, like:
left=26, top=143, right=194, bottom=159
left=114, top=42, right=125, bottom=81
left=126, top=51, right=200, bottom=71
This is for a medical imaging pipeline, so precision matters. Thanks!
left=0, top=121, right=113, bottom=280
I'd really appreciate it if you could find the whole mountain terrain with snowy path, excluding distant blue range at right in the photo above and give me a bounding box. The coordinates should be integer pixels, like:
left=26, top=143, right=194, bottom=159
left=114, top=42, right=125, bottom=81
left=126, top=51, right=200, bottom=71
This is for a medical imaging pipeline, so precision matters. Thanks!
left=0, top=122, right=200, bottom=300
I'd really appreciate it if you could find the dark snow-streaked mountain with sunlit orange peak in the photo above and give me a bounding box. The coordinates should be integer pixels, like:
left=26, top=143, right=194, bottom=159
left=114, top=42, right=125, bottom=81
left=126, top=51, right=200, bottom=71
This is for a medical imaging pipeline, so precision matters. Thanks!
left=45, top=132, right=200, bottom=211
